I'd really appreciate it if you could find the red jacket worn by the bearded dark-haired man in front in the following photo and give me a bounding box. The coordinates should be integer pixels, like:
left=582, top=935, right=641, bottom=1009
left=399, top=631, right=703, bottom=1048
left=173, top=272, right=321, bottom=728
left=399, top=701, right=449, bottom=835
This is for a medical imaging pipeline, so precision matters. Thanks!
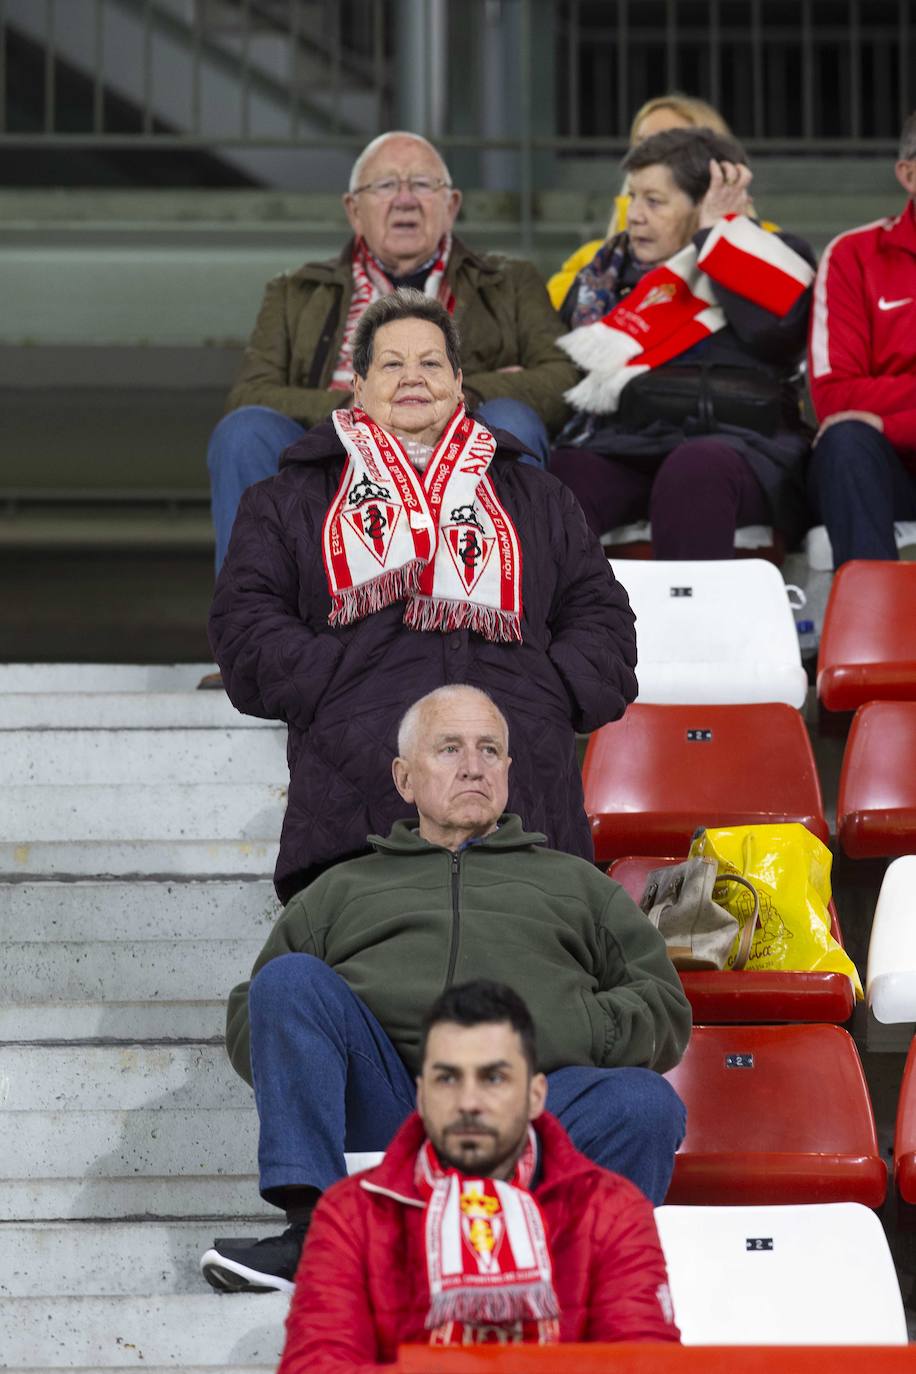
left=277, top=1113, right=680, bottom=1374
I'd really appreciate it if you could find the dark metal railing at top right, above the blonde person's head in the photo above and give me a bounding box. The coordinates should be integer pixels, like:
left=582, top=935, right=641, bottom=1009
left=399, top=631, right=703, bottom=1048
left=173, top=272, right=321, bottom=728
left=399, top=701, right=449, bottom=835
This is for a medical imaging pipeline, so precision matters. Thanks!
left=558, top=0, right=916, bottom=150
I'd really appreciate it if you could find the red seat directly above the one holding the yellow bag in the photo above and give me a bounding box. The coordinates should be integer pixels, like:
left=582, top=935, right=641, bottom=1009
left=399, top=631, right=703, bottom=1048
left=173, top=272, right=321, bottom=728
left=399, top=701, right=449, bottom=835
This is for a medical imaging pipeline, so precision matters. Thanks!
left=582, top=702, right=829, bottom=863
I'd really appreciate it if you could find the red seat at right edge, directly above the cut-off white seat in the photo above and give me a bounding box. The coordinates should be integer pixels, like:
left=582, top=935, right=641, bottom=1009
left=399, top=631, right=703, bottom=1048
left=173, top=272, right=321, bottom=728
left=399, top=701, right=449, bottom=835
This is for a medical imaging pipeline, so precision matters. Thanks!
left=836, top=701, right=916, bottom=859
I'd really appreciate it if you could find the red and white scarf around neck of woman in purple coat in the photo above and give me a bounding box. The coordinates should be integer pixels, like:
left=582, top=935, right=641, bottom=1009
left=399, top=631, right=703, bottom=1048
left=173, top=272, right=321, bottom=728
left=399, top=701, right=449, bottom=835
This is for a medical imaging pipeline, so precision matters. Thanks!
left=321, top=405, right=522, bottom=643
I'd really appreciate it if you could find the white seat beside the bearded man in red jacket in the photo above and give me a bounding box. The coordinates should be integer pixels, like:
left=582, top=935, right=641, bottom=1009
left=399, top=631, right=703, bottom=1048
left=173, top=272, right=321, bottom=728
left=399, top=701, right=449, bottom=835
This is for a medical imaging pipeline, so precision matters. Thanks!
left=655, top=1202, right=906, bottom=1341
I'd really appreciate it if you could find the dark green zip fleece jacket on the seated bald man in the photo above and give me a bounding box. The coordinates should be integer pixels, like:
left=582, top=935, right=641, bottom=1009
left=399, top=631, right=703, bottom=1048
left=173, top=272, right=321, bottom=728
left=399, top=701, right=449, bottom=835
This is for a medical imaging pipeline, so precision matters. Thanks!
left=227, top=815, right=691, bottom=1083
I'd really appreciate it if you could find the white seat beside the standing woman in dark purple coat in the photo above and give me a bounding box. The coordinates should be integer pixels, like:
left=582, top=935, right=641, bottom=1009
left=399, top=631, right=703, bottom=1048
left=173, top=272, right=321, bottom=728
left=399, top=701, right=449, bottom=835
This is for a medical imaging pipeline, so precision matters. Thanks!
left=611, top=558, right=808, bottom=706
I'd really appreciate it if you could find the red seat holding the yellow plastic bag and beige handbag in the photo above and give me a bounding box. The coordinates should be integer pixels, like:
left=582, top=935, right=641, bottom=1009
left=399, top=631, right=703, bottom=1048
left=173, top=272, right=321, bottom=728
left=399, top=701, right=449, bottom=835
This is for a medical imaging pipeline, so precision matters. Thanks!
left=607, top=855, right=856, bottom=1025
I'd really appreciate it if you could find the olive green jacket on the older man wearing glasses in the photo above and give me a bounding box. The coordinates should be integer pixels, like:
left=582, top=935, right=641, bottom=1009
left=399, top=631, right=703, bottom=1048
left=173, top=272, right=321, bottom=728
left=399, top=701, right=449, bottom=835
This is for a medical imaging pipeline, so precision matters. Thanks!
left=227, top=239, right=578, bottom=430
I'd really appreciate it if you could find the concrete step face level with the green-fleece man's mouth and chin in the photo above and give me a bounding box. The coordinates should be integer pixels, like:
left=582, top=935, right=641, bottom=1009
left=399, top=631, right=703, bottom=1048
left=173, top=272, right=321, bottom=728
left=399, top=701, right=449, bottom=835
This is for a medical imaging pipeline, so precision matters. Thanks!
left=0, top=782, right=286, bottom=844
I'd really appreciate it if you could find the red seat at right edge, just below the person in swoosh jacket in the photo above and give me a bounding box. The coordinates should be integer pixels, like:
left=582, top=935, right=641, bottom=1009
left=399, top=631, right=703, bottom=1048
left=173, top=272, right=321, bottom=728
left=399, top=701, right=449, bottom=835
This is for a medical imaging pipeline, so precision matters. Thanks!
left=817, top=561, right=916, bottom=710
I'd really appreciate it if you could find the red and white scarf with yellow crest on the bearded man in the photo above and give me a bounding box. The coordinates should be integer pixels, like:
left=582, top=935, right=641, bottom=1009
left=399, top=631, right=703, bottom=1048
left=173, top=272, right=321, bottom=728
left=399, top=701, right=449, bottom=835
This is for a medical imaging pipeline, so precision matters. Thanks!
left=415, top=1125, right=560, bottom=1345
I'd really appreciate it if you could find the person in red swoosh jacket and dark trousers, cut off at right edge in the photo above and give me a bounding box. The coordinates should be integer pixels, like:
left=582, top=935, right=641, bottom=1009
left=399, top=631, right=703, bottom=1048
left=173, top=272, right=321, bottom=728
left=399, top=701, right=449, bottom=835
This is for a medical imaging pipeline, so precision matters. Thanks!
left=809, top=111, right=916, bottom=567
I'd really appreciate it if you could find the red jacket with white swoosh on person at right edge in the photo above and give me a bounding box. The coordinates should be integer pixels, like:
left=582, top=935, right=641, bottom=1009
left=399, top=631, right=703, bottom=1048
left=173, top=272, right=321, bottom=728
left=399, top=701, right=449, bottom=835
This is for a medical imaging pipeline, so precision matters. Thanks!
left=809, top=201, right=916, bottom=467
